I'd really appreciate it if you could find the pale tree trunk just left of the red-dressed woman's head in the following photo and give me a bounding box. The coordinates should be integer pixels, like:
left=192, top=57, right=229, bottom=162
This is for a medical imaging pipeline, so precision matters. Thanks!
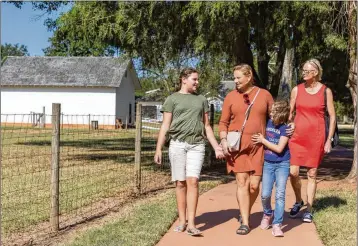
left=277, top=47, right=295, bottom=100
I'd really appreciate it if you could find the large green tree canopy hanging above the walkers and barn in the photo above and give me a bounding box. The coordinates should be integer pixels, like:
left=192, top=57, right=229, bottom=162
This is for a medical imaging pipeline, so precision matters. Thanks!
left=12, top=1, right=349, bottom=100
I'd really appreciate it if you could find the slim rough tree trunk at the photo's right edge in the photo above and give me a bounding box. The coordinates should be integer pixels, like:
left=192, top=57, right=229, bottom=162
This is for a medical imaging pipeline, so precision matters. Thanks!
left=347, top=1, right=358, bottom=182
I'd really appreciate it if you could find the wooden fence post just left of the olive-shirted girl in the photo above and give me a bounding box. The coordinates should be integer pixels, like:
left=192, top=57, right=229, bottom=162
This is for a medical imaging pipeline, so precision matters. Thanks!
left=134, top=103, right=142, bottom=193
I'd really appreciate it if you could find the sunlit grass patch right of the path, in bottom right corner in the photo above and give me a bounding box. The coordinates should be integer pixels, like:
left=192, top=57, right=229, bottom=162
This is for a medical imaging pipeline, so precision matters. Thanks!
left=314, top=188, right=357, bottom=246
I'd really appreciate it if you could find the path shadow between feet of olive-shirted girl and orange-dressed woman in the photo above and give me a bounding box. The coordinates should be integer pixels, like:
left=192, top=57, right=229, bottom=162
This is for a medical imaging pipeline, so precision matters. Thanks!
left=195, top=209, right=239, bottom=231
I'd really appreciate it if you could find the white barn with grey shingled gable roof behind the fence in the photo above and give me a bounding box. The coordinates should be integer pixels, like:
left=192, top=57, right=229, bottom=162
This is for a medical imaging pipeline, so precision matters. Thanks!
left=1, top=56, right=141, bottom=124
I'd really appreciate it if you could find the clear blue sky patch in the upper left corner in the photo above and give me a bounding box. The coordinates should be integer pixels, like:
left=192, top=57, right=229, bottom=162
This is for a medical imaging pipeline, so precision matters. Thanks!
left=1, top=2, right=70, bottom=56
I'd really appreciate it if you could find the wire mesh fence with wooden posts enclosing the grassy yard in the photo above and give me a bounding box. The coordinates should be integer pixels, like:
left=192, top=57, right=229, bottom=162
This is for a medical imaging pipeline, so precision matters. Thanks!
left=1, top=104, right=222, bottom=245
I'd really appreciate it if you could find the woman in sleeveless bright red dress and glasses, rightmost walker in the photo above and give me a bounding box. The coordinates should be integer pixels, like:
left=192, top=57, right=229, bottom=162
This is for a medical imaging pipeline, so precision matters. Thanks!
left=289, top=59, right=336, bottom=223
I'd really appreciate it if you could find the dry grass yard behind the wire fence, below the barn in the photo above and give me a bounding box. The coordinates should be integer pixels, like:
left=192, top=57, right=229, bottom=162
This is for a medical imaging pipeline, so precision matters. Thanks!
left=1, top=127, right=170, bottom=237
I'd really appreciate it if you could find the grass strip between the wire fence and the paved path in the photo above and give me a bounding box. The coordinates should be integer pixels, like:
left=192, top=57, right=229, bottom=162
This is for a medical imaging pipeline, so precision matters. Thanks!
left=66, top=178, right=226, bottom=246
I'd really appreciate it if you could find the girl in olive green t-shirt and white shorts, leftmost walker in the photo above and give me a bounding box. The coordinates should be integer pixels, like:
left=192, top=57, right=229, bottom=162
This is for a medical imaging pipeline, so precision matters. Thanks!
left=154, top=68, right=224, bottom=236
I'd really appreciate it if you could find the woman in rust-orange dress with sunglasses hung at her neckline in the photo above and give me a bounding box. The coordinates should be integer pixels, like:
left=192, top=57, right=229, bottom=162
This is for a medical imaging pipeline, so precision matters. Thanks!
left=219, top=64, right=273, bottom=235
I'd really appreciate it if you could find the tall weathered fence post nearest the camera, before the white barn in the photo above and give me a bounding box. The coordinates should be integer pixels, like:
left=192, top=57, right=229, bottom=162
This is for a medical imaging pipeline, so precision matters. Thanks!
left=50, top=103, right=61, bottom=232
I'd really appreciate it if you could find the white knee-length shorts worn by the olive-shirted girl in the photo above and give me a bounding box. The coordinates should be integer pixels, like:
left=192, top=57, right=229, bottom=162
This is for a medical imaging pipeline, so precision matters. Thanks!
left=169, top=140, right=205, bottom=181
